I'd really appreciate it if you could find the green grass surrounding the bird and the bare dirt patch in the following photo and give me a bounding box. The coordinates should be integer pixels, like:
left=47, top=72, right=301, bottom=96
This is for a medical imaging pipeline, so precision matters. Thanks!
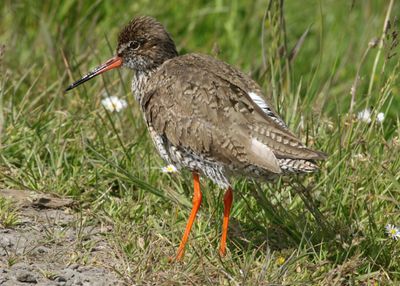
left=0, top=0, right=400, bottom=285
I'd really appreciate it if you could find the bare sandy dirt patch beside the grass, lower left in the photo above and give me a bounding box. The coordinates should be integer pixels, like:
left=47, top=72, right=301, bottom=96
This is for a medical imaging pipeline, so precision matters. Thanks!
left=0, top=190, right=124, bottom=286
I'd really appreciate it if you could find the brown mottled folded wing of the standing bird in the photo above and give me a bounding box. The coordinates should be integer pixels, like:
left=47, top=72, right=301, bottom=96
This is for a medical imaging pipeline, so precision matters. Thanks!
left=141, top=54, right=320, bottom=173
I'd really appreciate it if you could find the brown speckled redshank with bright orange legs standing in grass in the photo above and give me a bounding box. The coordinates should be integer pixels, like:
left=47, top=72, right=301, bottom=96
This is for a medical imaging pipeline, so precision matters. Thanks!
left=66, top=16, right=326, bottom=260
